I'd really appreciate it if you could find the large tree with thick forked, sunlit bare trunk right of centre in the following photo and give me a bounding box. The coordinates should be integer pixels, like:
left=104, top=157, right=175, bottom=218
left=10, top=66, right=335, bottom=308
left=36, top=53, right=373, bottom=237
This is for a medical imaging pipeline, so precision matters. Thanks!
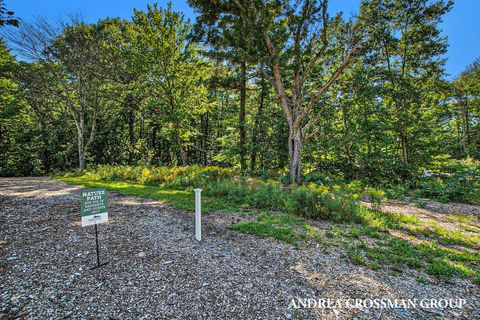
left=189, top=0, right=360, bottom=183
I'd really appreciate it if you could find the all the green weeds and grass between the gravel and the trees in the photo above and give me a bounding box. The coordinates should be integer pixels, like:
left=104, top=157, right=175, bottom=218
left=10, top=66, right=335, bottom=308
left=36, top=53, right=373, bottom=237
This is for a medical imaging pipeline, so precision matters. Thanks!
left=57, top=166, right=480, bottom=283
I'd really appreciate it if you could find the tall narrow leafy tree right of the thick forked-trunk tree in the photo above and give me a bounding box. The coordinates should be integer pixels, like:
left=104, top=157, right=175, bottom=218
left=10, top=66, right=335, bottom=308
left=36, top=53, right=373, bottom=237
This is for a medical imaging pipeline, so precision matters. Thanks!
left=369, top=0, right=453, bottom=165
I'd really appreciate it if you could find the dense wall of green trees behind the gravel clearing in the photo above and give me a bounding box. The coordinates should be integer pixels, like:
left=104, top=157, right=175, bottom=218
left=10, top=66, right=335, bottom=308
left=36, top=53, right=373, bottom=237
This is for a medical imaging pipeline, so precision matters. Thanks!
left=0, top=0, right=480, bottom=189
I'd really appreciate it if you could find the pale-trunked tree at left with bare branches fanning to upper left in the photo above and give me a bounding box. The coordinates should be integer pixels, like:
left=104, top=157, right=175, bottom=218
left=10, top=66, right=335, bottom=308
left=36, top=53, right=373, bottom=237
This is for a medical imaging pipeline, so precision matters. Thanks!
left=7, top=16, right=104, bottom=169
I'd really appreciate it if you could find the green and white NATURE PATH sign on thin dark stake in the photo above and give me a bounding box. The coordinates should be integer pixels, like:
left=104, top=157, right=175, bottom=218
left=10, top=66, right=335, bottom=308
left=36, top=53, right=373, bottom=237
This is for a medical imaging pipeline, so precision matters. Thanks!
left=80, top=189, right=108, bottom=269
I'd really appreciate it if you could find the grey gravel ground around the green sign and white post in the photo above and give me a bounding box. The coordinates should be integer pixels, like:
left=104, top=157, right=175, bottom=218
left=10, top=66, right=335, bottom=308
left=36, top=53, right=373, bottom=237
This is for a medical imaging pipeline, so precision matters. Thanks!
left=0, top=178, right=480, bottom=319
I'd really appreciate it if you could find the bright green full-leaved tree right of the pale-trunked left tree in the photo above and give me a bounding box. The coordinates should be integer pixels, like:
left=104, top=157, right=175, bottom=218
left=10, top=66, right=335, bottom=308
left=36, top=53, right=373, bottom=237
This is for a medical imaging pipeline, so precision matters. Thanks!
left=133, top=4, right=210, bottom=165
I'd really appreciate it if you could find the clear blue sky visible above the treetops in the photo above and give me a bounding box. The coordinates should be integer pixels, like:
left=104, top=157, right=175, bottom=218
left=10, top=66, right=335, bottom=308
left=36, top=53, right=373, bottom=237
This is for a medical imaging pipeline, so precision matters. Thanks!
left=5, top=0, right=480, bottom=78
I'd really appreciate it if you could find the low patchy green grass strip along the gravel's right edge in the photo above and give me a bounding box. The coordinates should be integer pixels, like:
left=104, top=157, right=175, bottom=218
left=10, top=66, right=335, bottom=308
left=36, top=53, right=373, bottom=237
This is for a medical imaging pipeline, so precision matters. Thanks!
left=230, top=208, right=480, bottom=281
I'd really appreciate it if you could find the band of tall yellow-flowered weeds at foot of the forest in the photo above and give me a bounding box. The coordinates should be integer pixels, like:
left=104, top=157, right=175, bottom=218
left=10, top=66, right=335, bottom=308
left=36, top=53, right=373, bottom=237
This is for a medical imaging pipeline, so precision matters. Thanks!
left=64, top=165, right=381, bottom=223
